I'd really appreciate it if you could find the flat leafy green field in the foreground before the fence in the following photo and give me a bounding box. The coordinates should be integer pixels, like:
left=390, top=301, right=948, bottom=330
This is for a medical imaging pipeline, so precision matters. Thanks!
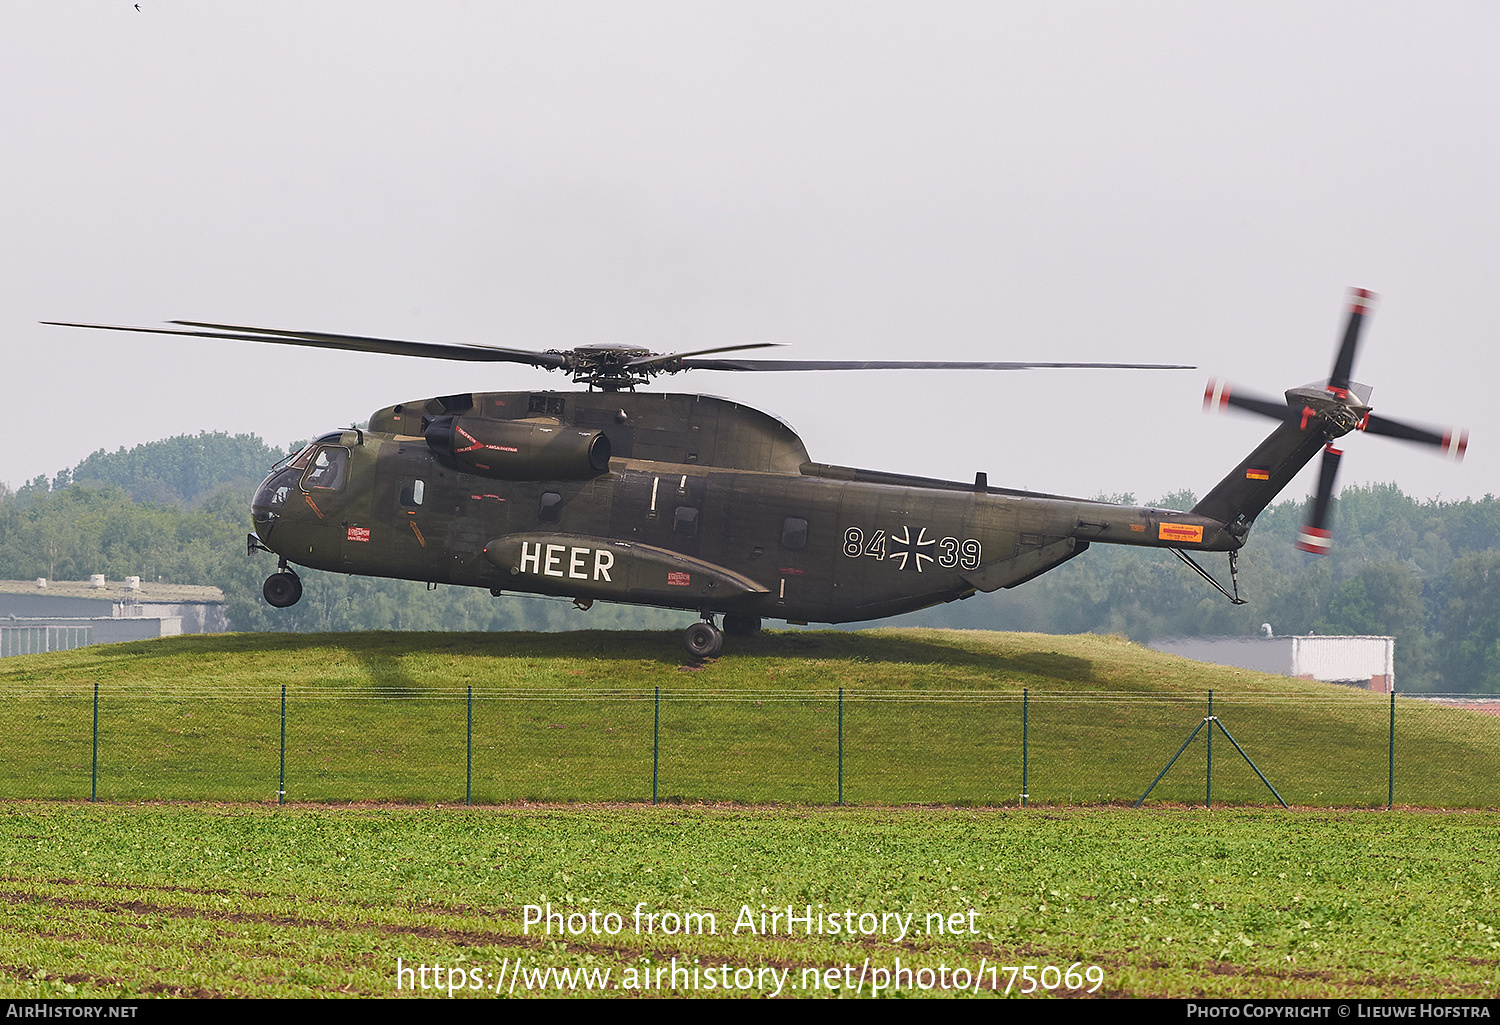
left=0, top=803, right=1500, bottom=999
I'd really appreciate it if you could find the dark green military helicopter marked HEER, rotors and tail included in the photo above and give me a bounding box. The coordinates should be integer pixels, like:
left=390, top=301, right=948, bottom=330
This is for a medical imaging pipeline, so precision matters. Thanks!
left=47, top=290, right=1467, bottom=659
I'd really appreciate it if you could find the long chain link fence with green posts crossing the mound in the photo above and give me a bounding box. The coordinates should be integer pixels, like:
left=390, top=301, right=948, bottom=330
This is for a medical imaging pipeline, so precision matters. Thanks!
left=0, top=686, right=1500, bottom=807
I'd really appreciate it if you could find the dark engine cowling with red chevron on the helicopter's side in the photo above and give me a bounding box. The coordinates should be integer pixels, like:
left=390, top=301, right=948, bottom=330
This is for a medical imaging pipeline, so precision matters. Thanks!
left=422, top=416, right=609, bottom=480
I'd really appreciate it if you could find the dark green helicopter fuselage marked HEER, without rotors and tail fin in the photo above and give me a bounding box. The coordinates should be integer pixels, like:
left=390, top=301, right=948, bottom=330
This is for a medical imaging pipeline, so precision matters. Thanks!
left=252, top=392, right=1244, bottom=623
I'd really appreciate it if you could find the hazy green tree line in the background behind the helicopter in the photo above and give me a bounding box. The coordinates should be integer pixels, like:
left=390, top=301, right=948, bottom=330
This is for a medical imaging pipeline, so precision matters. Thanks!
left=0, top=432, right=1500, bottom=693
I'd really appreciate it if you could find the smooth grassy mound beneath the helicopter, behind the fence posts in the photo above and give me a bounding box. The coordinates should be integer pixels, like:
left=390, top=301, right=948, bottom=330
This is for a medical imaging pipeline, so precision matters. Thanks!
left=0, top=630, right=1500, bottom=807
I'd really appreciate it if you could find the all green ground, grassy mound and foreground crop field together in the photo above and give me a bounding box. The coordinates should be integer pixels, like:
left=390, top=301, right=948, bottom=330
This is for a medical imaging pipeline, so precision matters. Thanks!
left=0, top=630, right=1500, bottom=998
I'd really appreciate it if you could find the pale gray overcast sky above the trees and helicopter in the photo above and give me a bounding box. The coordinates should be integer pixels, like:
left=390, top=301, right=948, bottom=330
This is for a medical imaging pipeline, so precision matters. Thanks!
left=0, top=0, right=1500, bottom=501
